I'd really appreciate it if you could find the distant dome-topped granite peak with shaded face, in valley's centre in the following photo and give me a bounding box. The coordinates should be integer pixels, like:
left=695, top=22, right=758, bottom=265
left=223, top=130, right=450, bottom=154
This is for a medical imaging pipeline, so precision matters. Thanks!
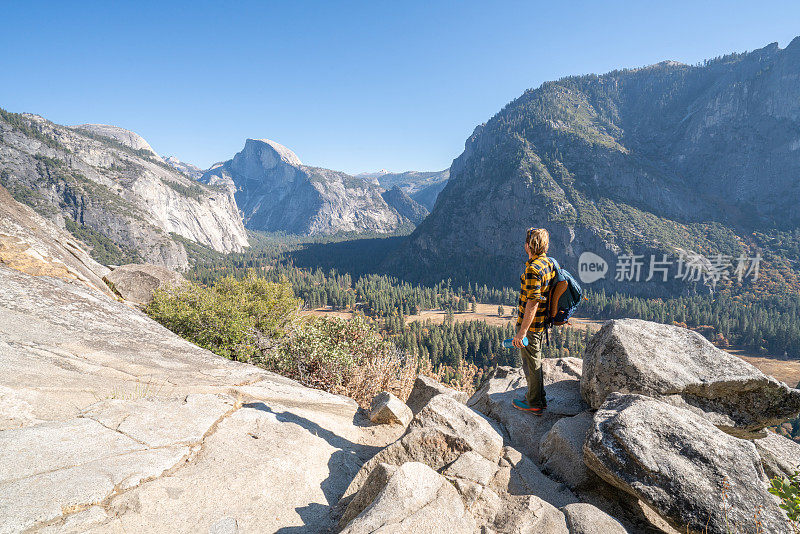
left=201, top=139, right=409, bottom=235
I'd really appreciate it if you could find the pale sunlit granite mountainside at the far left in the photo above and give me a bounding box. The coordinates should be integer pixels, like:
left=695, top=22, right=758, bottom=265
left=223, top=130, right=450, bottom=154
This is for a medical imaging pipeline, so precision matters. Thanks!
left=0, top=110, right=248, bottom=269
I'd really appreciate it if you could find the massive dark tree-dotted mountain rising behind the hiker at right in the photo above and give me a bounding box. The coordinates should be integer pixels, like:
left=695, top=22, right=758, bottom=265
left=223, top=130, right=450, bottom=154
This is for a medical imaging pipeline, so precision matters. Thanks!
left=385, top=38, right=800, bottom=294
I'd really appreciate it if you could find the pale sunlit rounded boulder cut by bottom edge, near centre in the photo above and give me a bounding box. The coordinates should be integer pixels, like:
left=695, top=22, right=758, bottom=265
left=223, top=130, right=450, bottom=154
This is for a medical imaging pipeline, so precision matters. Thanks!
left=342, top=462, right=475, bottom=534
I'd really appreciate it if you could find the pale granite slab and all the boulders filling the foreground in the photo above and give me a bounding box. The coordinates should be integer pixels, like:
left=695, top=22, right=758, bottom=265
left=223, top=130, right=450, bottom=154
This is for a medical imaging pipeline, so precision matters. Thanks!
left=0, top=193, right=800, bottom=534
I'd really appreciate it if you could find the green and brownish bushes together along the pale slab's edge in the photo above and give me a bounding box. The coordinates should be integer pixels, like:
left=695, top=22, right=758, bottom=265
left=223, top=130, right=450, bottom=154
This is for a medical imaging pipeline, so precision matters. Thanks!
left=145, top=273, right=417, bottom=408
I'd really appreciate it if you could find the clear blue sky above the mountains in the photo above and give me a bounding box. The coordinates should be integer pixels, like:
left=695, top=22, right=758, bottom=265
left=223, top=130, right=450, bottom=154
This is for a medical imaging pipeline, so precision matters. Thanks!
left=0, top=0, right=800, bottom=173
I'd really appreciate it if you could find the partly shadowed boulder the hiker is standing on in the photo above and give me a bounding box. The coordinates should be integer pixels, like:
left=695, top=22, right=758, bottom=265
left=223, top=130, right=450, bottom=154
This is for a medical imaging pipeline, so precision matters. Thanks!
left=467, top=358, right=587, bottom=458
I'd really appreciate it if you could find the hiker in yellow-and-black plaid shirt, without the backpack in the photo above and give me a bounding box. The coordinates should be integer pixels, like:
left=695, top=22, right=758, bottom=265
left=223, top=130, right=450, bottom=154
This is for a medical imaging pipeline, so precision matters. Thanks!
left=512, top=228, right=556, bottom=415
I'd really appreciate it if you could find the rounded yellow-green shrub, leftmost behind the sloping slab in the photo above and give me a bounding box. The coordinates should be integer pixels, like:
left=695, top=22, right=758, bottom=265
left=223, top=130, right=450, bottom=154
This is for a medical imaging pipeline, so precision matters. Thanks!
left=145, top=273, right=300, bottom=361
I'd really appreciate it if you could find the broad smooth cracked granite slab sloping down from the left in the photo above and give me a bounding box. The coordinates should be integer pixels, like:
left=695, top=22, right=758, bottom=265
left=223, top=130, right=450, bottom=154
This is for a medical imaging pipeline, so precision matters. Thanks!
left=0, top=263, right=403, bottom=534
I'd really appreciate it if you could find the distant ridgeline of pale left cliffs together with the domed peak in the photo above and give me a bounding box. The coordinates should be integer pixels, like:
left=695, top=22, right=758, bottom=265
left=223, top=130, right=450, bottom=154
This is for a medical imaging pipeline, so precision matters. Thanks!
left=0, top=109, right=449, bottom=269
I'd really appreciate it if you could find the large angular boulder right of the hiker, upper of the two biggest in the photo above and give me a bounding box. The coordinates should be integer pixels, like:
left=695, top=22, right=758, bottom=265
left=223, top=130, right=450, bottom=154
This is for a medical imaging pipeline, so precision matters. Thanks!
left=581, top=319, right=800, bottom=436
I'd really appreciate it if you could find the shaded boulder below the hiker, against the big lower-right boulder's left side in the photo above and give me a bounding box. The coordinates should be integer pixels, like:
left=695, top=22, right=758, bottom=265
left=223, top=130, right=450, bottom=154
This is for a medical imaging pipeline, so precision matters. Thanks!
left=539, top=411, right=593, bottom=489
